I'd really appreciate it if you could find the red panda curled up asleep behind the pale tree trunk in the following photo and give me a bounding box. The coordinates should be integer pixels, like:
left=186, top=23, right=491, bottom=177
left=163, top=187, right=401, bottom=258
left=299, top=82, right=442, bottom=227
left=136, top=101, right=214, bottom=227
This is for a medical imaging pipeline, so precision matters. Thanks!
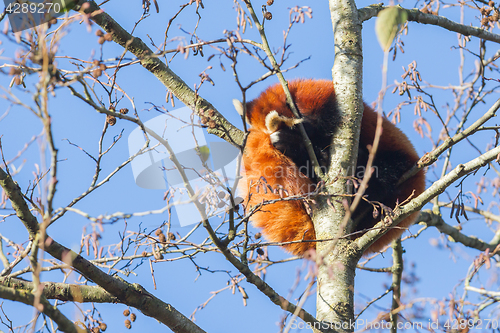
left=235, top=80, right=425, bottom=256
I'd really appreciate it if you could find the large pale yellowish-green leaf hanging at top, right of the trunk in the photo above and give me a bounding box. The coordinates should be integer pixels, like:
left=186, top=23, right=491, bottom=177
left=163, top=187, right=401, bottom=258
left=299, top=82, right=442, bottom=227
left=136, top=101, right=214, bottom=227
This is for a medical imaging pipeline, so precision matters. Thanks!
left=375, top=6, right=408, bottom=51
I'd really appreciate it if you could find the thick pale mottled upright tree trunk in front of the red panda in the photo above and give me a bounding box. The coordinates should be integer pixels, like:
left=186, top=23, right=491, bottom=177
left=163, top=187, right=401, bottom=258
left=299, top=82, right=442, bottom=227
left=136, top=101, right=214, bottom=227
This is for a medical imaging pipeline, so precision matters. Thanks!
left=313, top=0, right=363, bottom=333
